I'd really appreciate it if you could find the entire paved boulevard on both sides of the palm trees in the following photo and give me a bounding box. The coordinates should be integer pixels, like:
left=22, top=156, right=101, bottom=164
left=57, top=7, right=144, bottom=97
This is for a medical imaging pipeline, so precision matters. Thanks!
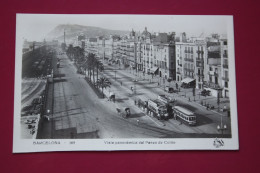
left=37, top=47, right=230, bottom=139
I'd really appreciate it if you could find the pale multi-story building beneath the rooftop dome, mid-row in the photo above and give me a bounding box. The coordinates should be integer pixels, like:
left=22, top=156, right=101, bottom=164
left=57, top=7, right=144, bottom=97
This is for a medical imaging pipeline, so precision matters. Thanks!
left=141, top=28, right=176, bottom=80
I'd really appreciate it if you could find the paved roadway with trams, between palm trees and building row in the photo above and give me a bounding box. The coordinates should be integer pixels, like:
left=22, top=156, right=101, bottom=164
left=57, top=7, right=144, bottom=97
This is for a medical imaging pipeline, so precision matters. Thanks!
left=99, top=61, right=230, bottom=134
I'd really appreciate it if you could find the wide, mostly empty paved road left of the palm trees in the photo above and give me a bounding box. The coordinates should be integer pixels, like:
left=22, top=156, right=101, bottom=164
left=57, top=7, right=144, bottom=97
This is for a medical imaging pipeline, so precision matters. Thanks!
left=38, top=49, right=211, bottom=138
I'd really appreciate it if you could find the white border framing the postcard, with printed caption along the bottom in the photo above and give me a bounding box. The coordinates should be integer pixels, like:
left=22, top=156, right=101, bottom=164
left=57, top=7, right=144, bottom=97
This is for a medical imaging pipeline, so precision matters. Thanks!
left=13, top=14, right=239, bottom=153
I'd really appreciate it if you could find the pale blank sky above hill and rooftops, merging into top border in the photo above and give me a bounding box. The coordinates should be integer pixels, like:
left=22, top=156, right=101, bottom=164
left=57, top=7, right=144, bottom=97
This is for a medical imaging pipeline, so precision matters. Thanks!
left=16, top=14, right=232, bottom=41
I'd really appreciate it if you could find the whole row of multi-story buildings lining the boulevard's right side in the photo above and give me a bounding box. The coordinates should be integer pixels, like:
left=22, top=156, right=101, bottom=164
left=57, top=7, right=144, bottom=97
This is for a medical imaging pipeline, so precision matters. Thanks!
left=74, top=28, right=229, bottom=97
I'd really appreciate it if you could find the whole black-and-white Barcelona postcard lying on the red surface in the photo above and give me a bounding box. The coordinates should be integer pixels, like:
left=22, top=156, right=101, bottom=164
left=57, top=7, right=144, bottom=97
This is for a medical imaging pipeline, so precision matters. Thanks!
left=13, top=14, right=239, bottom=153
